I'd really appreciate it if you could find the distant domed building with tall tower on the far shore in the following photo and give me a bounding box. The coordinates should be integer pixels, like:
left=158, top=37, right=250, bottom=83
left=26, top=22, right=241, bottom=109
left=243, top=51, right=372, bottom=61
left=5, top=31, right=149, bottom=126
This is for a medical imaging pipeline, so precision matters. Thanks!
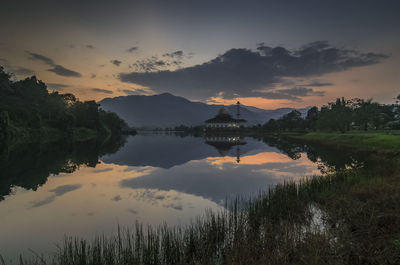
left=205, top=101, right=246, bottom=129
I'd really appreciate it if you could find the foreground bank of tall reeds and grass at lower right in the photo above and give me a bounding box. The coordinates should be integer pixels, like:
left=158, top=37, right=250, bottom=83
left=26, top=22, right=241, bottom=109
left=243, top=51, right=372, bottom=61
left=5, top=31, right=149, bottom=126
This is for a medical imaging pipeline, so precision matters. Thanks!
left=16, top=155, right=400, bottom=265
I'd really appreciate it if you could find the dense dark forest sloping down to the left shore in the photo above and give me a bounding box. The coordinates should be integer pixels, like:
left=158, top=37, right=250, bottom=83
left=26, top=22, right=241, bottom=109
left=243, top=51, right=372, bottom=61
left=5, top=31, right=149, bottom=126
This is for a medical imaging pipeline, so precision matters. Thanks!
left=0, top=67, right=129, bottom=143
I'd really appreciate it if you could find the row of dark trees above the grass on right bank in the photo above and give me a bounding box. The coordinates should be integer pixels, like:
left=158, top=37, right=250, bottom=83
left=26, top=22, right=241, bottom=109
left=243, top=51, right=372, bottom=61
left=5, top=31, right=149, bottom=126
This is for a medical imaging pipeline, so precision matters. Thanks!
left=262, top=95, right=400, bottom=132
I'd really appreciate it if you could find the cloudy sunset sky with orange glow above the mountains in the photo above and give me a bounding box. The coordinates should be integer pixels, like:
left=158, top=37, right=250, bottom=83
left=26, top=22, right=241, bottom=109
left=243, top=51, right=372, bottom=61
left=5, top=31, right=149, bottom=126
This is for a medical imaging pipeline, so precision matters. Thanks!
left=0, top=0, right=400, bottom=109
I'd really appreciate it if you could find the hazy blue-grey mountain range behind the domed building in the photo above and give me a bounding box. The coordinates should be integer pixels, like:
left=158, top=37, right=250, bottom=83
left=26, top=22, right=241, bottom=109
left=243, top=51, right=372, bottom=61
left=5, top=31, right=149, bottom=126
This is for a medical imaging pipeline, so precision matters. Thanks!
left=99, top=93, right=309, bottom=128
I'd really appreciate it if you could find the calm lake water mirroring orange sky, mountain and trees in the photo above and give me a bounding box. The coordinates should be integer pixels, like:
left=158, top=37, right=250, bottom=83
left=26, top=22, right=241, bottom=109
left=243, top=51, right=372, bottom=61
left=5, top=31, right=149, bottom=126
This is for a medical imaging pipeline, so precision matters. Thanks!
left=0, top=134, right=360, bottom=261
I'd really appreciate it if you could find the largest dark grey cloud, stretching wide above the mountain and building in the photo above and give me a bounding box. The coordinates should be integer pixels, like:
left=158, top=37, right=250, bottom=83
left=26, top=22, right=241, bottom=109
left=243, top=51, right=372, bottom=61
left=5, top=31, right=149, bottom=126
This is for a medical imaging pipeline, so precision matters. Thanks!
left=119, top=41, right=388, bottom=99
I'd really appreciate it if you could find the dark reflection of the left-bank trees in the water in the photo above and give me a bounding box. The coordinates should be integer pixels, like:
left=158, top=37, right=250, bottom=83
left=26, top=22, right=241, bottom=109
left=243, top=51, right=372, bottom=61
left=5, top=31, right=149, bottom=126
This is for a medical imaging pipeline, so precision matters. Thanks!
left=0, top=137, right=125, bottom=201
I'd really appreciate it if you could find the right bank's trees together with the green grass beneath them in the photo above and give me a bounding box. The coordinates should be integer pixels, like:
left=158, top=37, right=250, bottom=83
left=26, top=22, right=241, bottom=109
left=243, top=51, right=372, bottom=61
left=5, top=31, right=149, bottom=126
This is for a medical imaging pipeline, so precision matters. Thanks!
left=258, top=95, right=400, bottom=153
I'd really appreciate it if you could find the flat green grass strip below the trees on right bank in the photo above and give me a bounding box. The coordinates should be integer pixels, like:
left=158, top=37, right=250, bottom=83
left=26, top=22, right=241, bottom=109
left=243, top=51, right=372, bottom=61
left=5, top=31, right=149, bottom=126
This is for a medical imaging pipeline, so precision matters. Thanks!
left=295, top=132, right=400, bottom=152
